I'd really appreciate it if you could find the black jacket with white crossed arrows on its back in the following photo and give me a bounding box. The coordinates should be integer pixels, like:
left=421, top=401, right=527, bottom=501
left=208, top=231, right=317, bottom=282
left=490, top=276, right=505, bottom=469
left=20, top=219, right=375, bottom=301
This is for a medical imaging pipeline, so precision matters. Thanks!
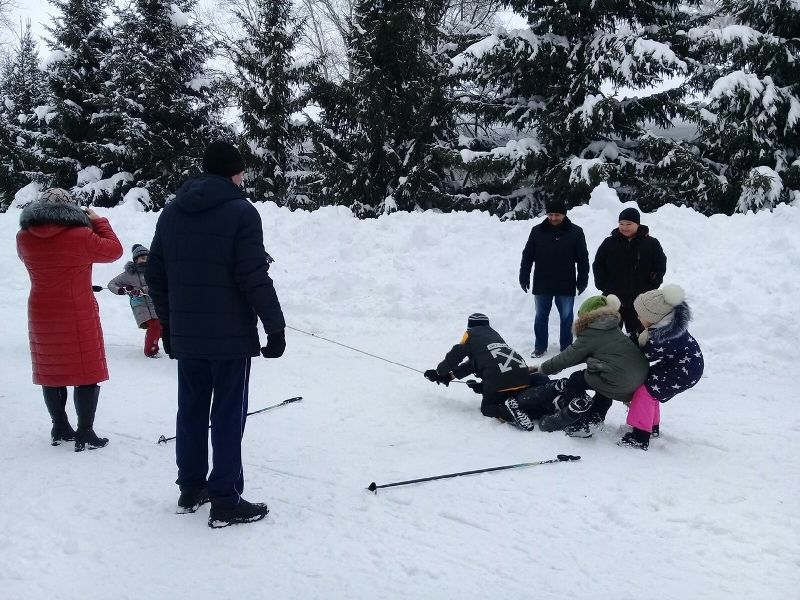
left=436, top=325, right=530, bottom=397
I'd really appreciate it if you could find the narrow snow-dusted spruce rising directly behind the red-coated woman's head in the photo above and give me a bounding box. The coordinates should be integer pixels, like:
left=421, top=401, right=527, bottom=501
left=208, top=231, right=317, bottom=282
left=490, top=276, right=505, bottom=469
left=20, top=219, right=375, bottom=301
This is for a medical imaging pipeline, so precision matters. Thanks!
left=38, top=0, right=111, bottom=188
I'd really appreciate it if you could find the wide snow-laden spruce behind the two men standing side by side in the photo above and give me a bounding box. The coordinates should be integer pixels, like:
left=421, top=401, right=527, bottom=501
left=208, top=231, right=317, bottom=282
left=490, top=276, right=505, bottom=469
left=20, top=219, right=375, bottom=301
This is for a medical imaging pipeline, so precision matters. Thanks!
left=455, top=0, right=696, bottom=216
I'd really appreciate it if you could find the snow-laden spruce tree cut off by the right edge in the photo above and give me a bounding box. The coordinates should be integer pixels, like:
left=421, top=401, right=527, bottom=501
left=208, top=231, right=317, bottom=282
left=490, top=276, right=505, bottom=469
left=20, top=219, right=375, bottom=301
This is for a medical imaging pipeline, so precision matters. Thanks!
left=688, top=0, right=800, bottom=212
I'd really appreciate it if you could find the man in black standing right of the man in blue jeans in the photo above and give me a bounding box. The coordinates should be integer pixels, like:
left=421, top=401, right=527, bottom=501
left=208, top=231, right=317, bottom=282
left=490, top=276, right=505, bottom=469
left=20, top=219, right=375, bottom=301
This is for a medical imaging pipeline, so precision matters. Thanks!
left=592, top=207, right=667, bottom=333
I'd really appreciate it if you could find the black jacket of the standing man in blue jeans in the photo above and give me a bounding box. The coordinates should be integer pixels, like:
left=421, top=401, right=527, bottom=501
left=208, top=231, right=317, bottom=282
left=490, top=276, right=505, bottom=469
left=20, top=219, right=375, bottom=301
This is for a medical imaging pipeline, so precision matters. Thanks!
left=519, top=217, right=589, bottom=296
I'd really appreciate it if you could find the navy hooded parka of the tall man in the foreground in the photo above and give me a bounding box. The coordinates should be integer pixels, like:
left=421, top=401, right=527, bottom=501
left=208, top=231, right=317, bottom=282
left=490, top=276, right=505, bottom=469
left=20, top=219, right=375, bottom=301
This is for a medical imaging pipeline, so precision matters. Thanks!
left=145, top=174, right=285, bottom=360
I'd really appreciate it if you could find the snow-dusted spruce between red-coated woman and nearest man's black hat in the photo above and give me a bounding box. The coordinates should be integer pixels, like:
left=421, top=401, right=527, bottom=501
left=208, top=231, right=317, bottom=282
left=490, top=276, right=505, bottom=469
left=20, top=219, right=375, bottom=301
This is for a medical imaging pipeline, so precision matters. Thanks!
left=102, top=0, right=220, bottom=207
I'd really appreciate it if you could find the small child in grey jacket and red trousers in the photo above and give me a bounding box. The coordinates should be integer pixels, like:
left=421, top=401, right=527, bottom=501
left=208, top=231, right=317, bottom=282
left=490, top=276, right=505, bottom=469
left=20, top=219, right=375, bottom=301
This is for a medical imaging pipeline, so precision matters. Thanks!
left=108, top=244, right=161, bottom=358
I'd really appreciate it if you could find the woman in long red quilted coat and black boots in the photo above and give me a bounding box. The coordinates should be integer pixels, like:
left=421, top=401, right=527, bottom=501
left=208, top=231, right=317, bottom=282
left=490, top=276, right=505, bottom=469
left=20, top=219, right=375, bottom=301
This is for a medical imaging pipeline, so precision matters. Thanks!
left=17, top=188, right=122, bottom=452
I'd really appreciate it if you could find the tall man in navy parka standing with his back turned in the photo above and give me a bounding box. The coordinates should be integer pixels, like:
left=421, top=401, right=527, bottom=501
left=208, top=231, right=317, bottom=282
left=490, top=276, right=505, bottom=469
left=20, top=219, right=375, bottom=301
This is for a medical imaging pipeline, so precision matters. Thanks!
left=146, top=141, right=286, bottom=527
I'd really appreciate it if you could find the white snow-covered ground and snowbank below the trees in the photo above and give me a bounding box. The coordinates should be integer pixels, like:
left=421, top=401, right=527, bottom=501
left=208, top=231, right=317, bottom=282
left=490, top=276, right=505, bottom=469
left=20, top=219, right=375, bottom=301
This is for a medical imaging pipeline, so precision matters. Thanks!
left=0, top=187, right=800, bottom=600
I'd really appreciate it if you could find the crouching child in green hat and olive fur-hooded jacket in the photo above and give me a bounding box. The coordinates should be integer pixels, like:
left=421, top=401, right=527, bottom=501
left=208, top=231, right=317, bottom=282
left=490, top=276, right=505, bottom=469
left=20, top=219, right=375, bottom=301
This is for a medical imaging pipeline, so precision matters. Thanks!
left=518, top=294, right=648, bottom=431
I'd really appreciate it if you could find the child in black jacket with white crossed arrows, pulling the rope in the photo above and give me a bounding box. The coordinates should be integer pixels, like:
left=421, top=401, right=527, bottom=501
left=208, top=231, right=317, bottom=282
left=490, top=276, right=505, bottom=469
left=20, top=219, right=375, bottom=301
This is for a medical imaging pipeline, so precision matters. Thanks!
left=424, top=313, right=533, bottom=431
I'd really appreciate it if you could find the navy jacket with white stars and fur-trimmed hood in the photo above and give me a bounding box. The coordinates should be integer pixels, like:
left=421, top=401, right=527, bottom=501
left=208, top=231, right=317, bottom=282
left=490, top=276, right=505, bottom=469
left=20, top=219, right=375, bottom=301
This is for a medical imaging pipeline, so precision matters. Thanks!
left=631, top=302, right=705, bottom=402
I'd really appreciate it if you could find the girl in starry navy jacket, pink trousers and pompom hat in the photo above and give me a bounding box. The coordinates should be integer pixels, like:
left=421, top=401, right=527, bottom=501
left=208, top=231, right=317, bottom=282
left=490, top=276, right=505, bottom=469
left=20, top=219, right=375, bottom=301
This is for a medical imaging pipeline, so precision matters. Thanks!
left=619, top=285, right=704, bottom=450
